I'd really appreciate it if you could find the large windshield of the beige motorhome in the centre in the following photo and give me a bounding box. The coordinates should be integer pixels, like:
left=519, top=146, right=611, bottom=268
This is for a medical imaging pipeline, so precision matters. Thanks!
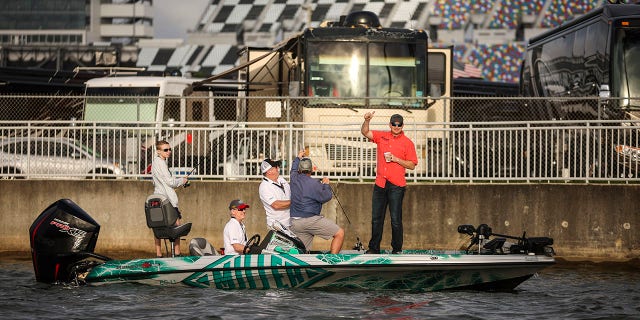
left=307, top=41, right=426, bottom=107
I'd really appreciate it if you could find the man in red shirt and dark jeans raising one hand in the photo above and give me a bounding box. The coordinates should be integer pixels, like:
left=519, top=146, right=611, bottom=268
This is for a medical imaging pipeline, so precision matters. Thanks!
left=360, top=111, right=418, bottom=253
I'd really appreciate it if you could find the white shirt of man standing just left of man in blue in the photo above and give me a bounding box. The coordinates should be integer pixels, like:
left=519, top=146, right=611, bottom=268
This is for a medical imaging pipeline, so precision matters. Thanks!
left=259, top=176, right=291, bottom=228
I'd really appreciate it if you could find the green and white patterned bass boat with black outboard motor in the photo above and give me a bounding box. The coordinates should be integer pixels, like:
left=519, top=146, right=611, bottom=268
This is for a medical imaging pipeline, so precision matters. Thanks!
left=29, top=198, right=555, bottom=291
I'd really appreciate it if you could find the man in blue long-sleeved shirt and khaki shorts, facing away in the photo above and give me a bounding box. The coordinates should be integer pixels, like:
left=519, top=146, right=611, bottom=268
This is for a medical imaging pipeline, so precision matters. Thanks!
left=290, top=150, right=344, bottom=253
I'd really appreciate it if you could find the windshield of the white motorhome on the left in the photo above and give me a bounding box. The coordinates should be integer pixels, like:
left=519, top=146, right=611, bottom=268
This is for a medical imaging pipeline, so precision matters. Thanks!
left=84, top=87, right=160, bottom=122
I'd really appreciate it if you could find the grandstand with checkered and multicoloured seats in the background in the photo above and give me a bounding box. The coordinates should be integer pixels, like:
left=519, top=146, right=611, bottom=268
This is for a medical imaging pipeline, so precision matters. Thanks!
left=137, top=0, right=604, bottom=82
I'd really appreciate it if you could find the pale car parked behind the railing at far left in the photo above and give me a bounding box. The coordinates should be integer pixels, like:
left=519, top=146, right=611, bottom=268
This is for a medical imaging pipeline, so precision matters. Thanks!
left=0, top=137, right=124, bottom=179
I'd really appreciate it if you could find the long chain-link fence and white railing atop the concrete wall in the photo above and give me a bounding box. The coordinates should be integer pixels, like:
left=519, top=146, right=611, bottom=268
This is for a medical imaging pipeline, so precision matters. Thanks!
left=0, top=95, right=640, bottom=182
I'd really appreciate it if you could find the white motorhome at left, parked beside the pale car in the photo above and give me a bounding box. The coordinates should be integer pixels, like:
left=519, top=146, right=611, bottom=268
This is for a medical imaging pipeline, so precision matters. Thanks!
left=82, top=76, right=264, bottom=176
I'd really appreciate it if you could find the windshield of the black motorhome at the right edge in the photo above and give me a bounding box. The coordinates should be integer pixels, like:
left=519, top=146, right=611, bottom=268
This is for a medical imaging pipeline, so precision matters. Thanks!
left=612, top=28, right=640, bottom=107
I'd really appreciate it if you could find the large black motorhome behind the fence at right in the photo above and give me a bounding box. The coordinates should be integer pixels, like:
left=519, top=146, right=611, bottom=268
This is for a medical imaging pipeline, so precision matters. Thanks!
left=520, top=4, right=640, bottom=176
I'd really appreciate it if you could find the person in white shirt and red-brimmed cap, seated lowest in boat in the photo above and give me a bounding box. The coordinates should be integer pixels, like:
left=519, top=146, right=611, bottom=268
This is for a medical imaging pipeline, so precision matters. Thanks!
left=222, top=199, right=249, bottom=255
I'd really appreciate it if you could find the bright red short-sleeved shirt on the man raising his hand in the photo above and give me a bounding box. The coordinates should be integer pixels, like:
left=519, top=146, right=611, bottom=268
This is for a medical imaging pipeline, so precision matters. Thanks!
left=371, top=130, right=418, bottom=188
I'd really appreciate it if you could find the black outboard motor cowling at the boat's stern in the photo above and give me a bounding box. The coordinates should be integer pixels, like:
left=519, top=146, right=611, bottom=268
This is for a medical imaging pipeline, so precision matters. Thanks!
left=29, top=199, right=100, bottom=283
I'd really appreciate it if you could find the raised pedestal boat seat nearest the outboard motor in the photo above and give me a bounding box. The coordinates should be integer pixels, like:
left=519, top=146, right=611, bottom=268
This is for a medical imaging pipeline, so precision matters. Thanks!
left=144, top=194, right=191, bottom=257
